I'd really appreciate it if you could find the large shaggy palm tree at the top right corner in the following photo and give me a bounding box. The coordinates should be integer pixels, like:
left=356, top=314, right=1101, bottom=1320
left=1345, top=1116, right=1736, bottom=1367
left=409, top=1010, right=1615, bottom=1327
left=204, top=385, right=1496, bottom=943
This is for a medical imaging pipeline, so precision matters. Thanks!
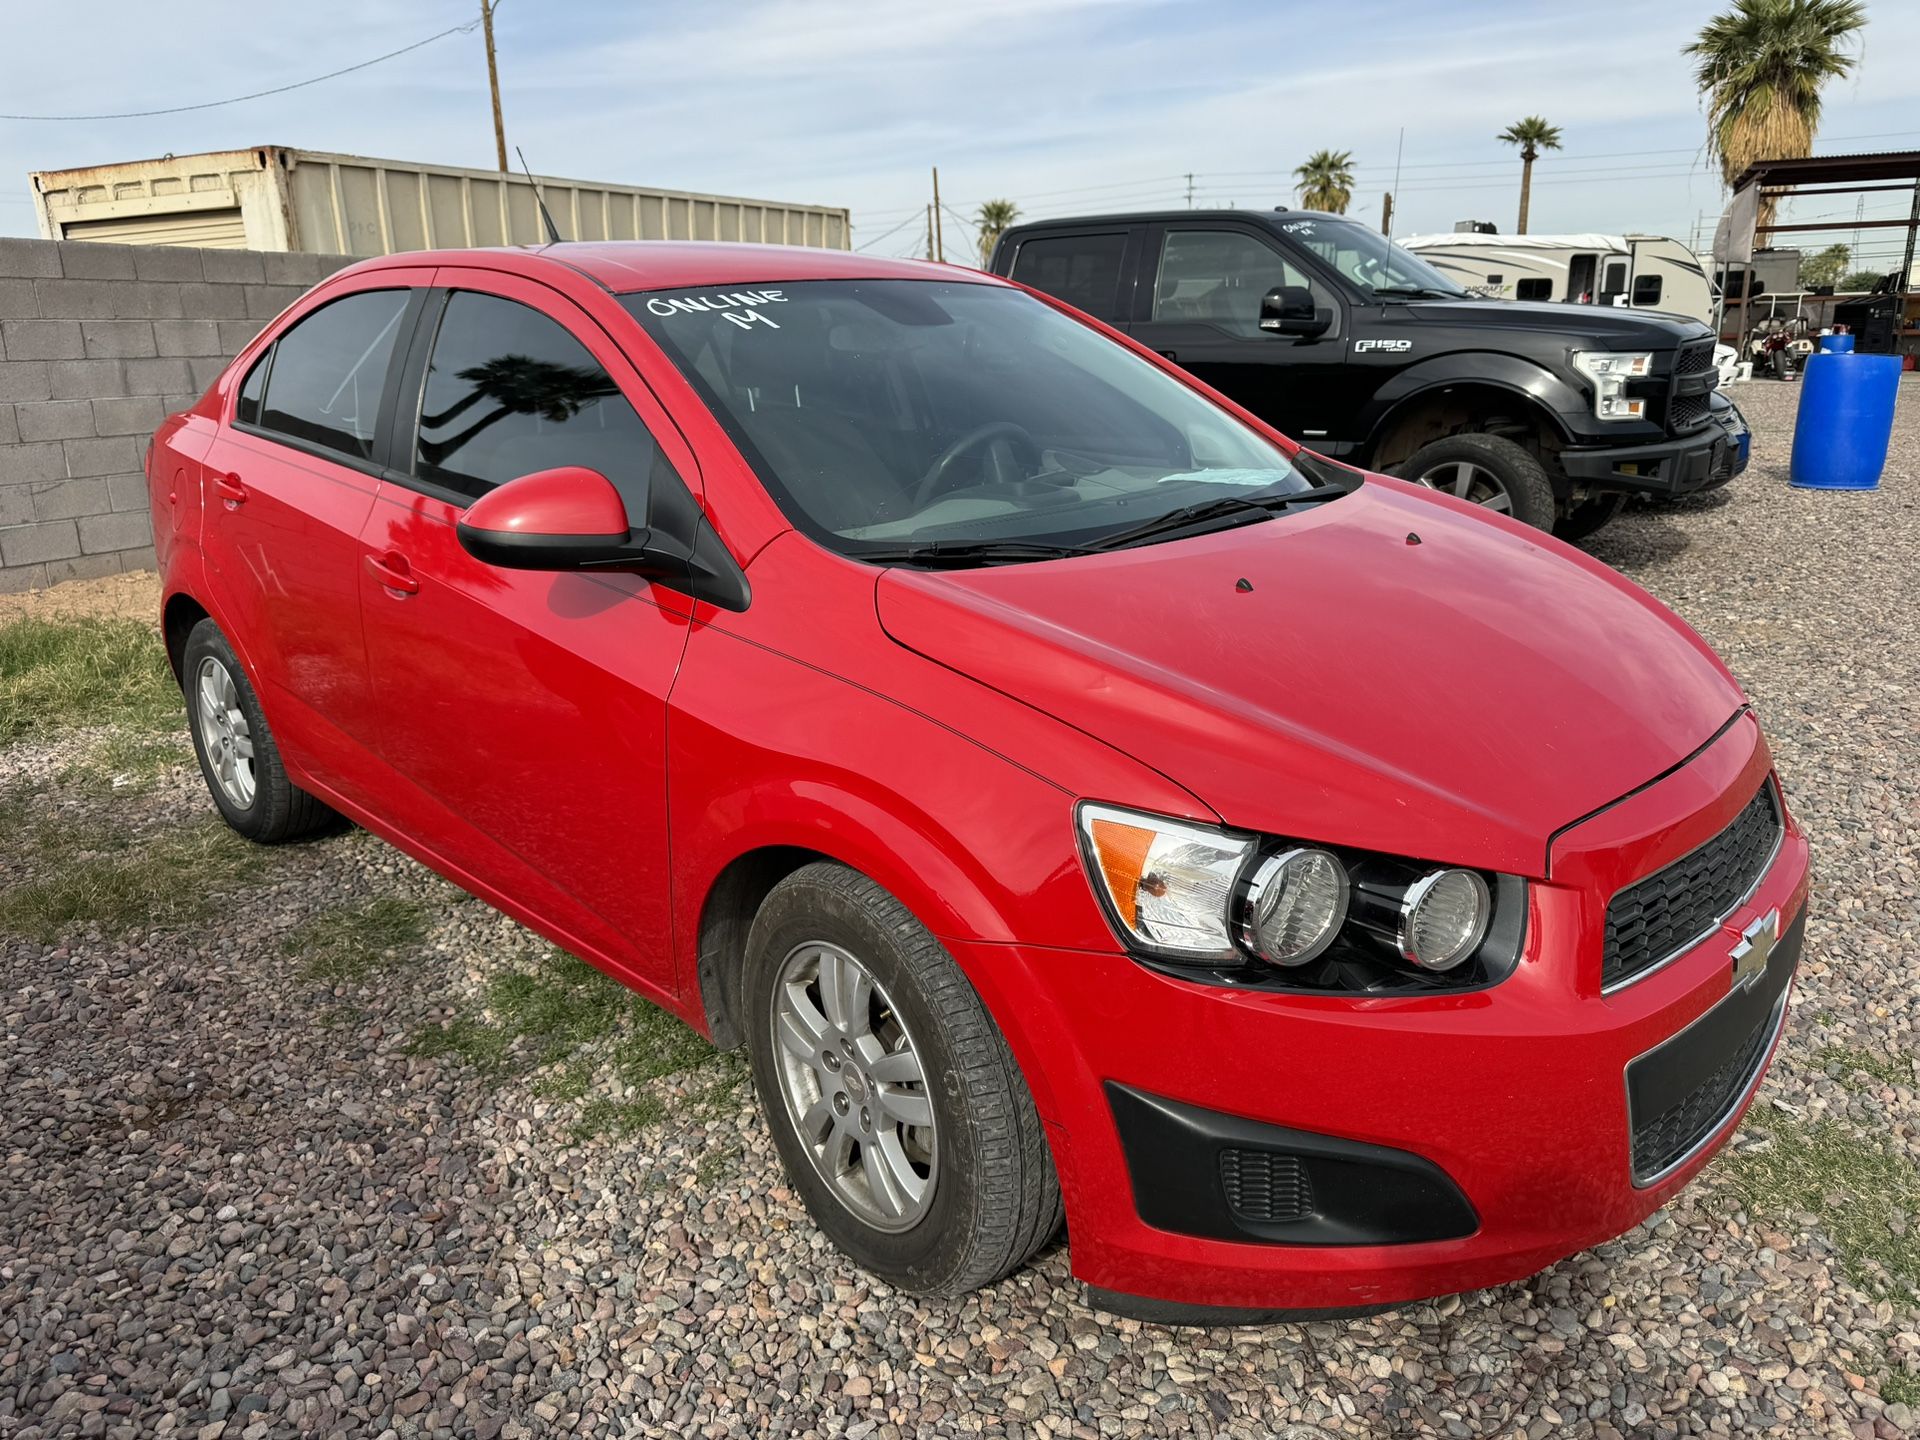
left=1680, top=0, right=1866, bottom=225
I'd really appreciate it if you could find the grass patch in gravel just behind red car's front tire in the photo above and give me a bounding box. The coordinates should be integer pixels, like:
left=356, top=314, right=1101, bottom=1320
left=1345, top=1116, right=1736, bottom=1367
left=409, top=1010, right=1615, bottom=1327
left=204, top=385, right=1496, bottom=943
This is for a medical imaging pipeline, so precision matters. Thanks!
left=411, top=950, right=739, bottom=1139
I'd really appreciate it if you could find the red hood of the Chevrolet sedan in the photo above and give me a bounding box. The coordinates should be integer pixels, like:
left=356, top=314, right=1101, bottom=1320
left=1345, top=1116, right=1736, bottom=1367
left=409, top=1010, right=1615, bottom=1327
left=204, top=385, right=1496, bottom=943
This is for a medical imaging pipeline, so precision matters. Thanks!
left=876, top=476, right=1743, bottom=876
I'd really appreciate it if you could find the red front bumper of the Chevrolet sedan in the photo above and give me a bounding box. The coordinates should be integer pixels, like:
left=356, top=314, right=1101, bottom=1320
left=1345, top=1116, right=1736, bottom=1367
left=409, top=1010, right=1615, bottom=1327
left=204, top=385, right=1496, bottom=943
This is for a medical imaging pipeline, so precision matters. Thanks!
left=954, top=722, right=1807, bottom=1323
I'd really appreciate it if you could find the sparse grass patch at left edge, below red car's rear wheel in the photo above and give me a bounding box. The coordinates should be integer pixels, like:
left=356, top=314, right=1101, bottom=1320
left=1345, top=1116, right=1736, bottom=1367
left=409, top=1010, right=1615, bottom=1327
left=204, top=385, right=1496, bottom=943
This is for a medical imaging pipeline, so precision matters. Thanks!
left=0, top=820, right=261, bottom=945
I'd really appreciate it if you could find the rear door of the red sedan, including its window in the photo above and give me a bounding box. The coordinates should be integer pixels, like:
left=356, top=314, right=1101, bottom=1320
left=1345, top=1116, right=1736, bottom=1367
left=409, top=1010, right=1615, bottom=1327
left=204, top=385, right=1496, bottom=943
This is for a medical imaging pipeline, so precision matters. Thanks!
left=202, top=269, right=432, bottom=797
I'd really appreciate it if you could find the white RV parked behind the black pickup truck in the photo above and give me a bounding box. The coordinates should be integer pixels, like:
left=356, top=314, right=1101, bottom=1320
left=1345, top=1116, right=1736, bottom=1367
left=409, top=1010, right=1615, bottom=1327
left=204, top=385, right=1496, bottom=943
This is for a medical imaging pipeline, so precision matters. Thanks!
left=1400, top=230, right=1740, bottom=386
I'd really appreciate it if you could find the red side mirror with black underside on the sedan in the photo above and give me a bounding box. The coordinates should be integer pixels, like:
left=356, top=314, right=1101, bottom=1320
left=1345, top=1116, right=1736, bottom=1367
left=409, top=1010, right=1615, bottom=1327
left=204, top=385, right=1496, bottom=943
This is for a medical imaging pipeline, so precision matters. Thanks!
left=459, top=465, right=666, bottom=574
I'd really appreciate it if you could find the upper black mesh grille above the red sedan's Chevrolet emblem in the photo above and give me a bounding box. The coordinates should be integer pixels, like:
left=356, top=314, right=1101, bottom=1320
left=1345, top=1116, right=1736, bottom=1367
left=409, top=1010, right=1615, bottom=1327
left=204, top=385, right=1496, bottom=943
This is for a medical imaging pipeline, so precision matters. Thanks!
left=1599, top=783, right=1780, bottom=989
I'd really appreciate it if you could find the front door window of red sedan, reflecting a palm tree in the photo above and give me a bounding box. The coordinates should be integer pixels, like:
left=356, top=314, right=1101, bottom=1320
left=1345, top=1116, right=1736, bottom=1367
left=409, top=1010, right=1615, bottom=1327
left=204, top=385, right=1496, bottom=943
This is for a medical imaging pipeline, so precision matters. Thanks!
left=415, top=290, right=655, bottom=497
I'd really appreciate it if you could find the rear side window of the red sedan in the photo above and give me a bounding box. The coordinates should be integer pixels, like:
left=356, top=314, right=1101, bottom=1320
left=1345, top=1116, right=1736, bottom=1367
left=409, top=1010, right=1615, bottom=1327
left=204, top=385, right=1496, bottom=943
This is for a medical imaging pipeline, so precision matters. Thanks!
left=259, top=290, right=409, bottom=461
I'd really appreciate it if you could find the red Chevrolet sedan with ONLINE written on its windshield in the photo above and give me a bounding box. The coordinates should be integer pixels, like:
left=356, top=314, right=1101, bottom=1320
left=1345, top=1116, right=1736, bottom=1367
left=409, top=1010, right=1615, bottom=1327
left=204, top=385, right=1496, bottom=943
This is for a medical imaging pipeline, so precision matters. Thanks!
left=148, top=244, right=1807, bottom=1319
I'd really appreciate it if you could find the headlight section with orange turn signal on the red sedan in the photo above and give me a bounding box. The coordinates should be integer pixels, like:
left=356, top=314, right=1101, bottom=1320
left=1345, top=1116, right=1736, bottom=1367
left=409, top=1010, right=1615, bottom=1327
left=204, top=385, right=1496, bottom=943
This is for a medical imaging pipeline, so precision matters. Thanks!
left=1079, top=804, right=1254, bottom=960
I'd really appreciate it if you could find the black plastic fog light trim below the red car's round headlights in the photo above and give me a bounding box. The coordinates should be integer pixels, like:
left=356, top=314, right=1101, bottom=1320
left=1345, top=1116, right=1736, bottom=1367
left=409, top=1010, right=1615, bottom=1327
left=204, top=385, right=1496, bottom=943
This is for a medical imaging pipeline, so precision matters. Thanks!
left=1106, top=1081, right=1480, bottom=1246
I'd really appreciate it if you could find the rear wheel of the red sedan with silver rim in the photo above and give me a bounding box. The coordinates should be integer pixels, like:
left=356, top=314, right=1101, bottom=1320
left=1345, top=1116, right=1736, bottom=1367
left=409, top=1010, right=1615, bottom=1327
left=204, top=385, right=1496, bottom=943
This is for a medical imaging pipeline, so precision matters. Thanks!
left=180, top=620, right=338, bottom=845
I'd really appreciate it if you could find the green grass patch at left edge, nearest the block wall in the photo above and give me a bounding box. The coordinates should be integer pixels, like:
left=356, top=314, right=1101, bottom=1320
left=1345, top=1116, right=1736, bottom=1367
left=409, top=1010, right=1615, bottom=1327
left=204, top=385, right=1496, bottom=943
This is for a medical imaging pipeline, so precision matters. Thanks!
left=0, top=616, right=184, bottom=743
